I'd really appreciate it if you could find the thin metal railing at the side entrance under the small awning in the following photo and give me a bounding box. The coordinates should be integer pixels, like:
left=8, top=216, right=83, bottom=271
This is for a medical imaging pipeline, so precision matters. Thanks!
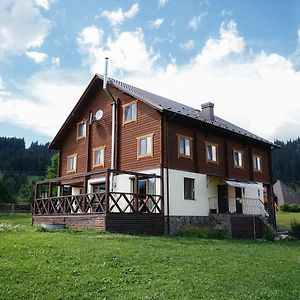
left=209, top=197, right=268, bottom=216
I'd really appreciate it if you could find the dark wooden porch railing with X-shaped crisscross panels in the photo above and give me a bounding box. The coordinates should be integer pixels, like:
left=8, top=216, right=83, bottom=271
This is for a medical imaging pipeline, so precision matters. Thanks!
left=32, top=192, right=163, bottom=215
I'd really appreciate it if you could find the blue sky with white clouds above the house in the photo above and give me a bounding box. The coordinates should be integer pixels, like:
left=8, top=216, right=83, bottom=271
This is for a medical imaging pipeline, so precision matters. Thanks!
left=0, top=0, right=300, bottom=145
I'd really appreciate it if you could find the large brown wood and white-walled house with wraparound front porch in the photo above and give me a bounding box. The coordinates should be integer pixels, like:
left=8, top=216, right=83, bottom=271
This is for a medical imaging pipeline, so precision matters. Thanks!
left=32, top=74, right=276, bottom=237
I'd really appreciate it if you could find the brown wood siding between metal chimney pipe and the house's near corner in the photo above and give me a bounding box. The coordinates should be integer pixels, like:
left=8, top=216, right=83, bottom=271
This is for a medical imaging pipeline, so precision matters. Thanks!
left=110, top=88, right=161, bottom=171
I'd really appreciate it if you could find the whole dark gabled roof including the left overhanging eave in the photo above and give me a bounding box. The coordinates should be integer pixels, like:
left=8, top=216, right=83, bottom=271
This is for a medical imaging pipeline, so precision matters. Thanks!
left=49, top=74, right=278, bottom=149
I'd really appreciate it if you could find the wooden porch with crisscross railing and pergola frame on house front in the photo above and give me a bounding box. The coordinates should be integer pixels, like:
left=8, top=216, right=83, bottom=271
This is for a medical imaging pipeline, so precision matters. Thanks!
left=32, top=169, right=164, bottom=234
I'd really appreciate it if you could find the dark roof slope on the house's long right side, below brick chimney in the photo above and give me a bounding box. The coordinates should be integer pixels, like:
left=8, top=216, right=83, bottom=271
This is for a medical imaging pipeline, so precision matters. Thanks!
left=97, top=74, right=278, bottom=147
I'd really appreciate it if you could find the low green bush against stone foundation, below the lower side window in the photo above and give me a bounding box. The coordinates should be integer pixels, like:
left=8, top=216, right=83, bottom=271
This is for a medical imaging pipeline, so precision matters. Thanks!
left=182, top=225, right=227, bottom=239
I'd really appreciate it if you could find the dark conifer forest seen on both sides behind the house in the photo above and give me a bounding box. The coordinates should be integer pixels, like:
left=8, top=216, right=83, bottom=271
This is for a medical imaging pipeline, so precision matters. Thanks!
left=0, top=137, right=300, bottom=203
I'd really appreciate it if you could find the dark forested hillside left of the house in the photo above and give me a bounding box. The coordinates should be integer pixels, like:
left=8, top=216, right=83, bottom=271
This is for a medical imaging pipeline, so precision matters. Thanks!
left=0, top=137, right=54, bottom=203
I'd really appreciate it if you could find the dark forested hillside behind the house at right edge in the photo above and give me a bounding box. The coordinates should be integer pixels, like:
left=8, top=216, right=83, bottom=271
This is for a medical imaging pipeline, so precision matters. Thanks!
left=272, top=138, right=300, bottom=190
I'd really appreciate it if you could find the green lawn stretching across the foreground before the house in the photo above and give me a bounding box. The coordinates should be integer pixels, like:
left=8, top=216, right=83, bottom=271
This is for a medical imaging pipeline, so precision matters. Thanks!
left=0, top=215, right=300, bottom=300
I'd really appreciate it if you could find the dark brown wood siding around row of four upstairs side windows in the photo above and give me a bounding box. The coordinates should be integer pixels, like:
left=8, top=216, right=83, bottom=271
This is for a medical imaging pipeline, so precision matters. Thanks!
left=168, top=118, right=270, bottom=183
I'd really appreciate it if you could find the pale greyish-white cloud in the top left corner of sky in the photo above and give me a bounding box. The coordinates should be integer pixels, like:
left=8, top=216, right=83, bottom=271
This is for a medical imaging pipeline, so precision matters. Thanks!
left=0, top=0, right=51, bottom=60
